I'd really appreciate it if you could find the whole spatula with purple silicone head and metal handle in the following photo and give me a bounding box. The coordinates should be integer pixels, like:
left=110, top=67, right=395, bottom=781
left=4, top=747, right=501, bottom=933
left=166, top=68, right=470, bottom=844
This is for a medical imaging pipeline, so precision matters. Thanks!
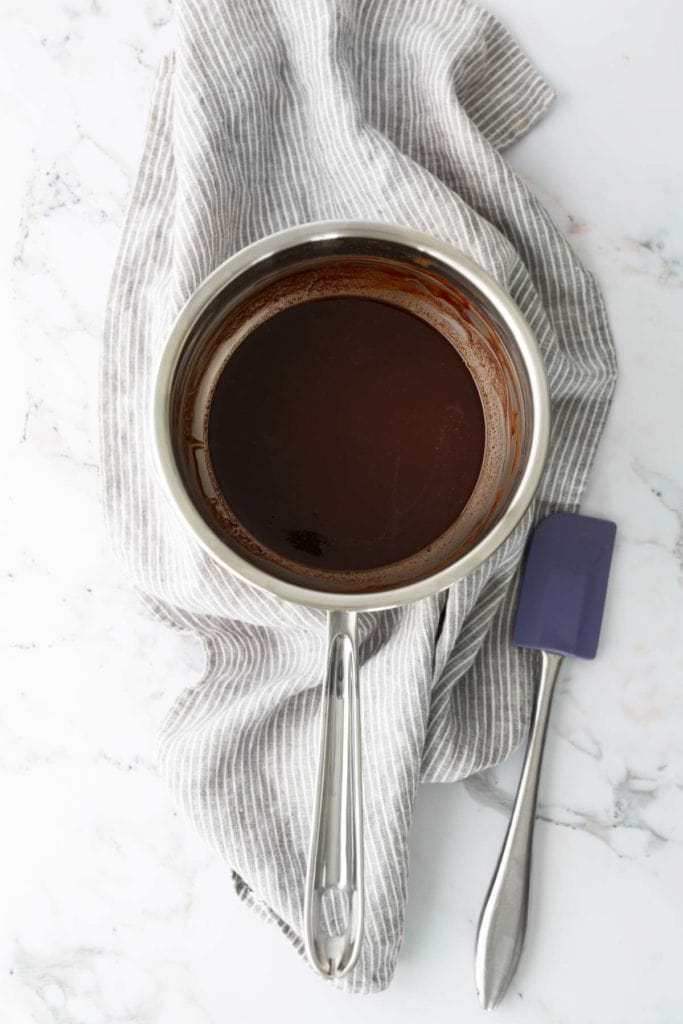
left=474, top=513, right=616, bottom=1010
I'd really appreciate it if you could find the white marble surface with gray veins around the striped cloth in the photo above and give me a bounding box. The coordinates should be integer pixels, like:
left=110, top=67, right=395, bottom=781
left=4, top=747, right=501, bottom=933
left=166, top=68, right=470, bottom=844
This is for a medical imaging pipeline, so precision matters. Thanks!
left=0, top=0, right=683, bottom=1024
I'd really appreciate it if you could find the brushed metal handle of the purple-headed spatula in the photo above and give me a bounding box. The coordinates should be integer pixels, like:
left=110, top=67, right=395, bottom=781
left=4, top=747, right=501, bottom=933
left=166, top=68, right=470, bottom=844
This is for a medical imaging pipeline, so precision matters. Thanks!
left=474, top=651, right=562, bottom=1010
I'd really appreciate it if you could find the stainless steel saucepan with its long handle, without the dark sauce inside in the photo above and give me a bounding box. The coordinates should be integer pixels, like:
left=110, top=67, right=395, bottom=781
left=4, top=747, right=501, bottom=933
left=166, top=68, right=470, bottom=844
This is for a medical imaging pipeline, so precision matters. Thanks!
left=153, top=221, right=550, bottom=978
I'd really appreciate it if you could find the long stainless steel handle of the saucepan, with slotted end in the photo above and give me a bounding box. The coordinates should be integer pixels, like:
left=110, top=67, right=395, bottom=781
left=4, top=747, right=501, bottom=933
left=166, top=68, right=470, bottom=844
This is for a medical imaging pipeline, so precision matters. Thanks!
left=303, top=611, right=364, bottom=978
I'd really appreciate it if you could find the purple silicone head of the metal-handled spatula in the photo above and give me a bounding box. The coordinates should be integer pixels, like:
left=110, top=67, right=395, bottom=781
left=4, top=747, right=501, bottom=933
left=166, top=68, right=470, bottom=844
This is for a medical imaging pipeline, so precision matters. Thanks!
left=512, top=512, right=616, bottom=657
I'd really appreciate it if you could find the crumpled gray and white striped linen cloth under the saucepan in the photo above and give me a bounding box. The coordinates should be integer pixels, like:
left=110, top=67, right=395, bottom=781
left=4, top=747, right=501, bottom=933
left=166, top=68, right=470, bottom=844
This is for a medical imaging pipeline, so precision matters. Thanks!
left=101, top=0, right=615, bottom=992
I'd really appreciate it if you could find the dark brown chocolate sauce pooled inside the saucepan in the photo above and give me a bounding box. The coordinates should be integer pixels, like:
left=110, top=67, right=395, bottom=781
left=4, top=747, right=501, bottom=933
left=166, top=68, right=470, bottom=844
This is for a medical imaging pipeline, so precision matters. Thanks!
left=208, top=297, right=484, bottom=571
